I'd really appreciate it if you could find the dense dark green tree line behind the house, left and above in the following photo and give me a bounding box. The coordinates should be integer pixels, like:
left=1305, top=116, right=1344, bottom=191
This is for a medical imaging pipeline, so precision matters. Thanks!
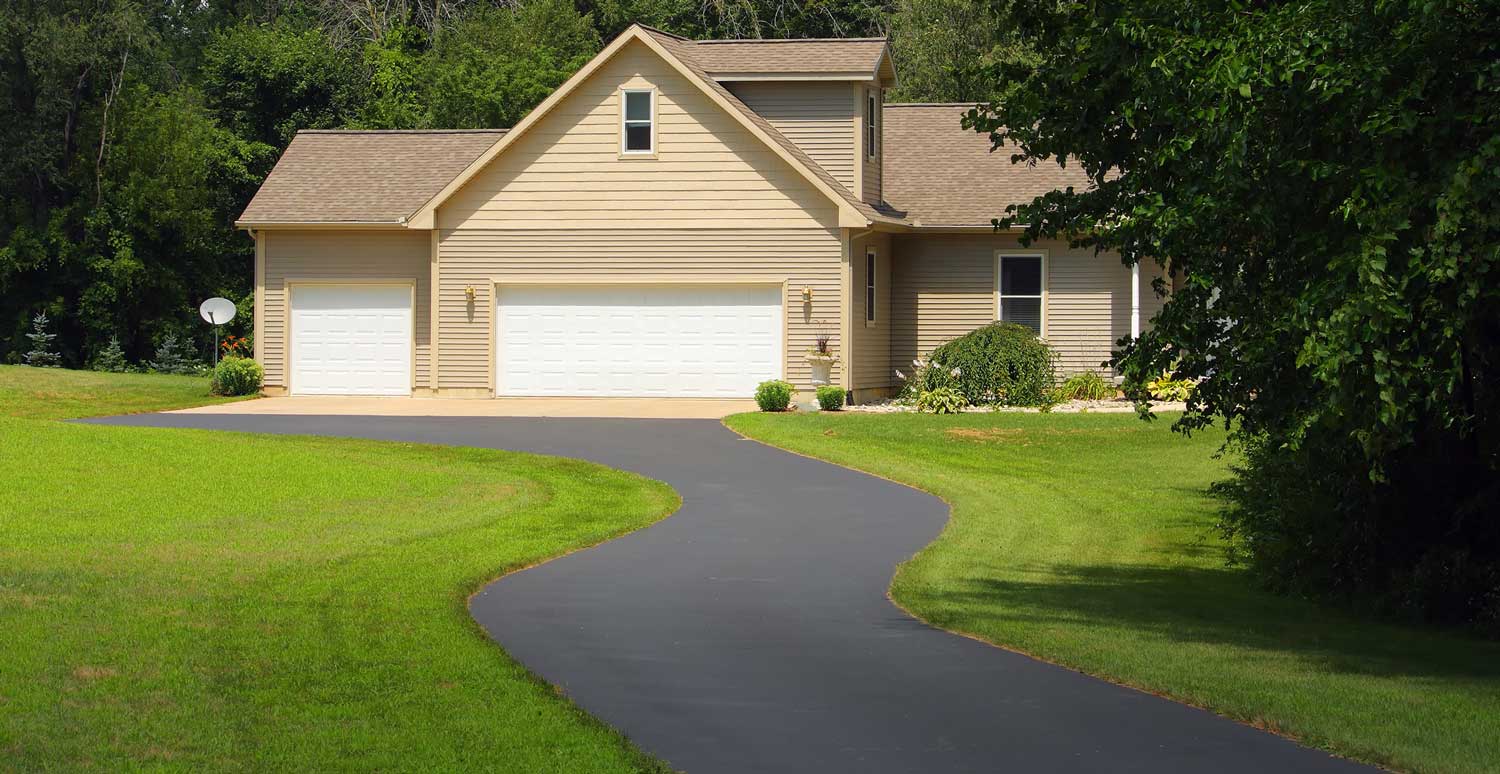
left=0, top=0, right=1004, bottom=366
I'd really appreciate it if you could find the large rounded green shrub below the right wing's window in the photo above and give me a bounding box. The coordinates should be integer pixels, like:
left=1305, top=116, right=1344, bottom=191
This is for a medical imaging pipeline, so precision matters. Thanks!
left=906, top=323, right=1056, bottom=407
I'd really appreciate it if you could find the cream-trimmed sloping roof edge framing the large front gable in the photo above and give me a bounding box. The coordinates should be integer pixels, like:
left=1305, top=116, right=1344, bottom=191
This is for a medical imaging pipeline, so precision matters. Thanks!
left=410, top=24, right=900, bottom=228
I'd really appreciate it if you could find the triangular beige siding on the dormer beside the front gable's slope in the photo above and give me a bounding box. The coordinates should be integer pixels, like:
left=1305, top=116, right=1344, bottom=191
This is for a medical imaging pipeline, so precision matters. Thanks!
left=726, top=81, right=858, bottom=192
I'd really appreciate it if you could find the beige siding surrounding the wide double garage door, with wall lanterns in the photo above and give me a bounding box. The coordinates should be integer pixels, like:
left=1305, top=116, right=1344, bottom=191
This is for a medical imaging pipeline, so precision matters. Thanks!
left=438, top=228, right=843, bottom=390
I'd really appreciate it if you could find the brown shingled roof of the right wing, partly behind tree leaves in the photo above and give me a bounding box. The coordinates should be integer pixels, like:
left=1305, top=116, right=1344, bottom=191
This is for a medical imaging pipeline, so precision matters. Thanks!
left=882, top=104, right=1092, bottom=227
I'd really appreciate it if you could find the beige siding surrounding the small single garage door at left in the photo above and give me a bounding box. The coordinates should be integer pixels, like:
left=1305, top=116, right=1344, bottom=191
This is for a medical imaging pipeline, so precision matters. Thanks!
left=255, top=230, right=432, bottom=387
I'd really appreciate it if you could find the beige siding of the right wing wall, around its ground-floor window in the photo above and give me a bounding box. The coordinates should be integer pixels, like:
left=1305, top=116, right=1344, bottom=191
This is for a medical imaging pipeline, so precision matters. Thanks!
left=888, top=234, right=1163, bottom=374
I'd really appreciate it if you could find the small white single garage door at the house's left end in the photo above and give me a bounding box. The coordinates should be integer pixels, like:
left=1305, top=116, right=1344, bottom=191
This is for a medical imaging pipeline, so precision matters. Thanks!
left=291, top=285, right=413, bottom=395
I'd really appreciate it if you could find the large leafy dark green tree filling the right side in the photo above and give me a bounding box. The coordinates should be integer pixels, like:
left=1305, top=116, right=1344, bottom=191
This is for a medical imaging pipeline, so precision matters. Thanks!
left=974, top=0, right=1500, bottom=629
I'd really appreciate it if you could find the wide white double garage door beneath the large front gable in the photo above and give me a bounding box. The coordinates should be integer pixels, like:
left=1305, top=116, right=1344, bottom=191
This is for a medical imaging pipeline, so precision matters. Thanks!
left=495, top=285, right=782, bottom=398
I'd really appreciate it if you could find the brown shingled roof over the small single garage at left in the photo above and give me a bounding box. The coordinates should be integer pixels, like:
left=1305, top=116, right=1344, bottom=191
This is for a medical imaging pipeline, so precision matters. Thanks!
left=236, top=129, right=506, bottom=227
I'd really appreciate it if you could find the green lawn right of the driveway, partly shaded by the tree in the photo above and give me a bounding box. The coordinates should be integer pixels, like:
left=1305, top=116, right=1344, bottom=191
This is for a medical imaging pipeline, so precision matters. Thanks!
left=728, top=413, right=1500, bottom=771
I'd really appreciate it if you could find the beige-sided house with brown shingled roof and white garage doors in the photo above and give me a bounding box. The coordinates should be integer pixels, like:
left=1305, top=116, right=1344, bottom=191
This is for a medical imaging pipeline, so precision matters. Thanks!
left=237, top=26, right=1160, bottom=401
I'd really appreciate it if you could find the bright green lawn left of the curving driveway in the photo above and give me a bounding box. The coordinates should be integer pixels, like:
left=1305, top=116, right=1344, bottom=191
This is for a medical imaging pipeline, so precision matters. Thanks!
left=0, top=368, right=678, bottom=773
